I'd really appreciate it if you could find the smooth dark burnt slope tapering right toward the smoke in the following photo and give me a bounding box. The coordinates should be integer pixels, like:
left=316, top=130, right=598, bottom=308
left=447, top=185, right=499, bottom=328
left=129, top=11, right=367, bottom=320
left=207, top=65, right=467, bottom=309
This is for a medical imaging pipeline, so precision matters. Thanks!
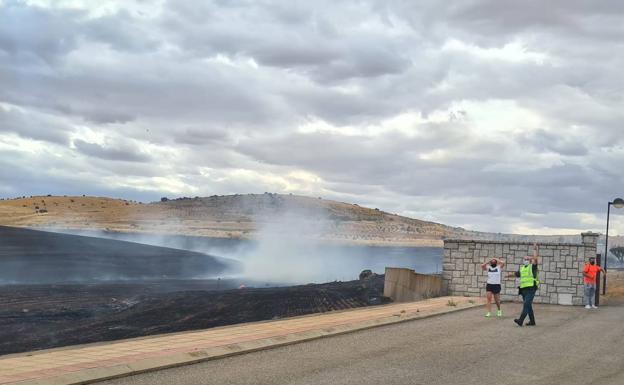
left=0, top=226, right=240, bottom=284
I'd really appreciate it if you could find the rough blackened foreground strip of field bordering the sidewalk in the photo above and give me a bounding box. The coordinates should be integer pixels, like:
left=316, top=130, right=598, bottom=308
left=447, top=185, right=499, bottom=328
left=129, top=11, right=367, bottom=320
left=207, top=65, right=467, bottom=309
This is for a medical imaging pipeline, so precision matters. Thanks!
left=0, top=276, right=384, bottom=354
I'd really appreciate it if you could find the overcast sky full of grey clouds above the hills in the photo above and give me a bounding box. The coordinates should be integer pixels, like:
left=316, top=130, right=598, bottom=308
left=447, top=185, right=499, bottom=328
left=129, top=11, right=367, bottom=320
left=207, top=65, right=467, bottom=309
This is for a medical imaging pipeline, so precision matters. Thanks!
left=0, top=0, right=624, bottom=234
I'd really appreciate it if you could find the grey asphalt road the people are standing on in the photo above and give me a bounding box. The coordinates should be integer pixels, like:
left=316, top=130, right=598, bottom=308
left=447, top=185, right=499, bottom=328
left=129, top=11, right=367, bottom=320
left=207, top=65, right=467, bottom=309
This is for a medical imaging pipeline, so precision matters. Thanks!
left=100, top=304, right=624, bottom=385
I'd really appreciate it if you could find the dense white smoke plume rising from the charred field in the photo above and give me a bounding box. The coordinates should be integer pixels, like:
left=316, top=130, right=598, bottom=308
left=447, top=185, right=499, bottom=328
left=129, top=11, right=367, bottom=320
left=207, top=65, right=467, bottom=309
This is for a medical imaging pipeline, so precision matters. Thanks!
left=235, top=210, right=442, bottom=284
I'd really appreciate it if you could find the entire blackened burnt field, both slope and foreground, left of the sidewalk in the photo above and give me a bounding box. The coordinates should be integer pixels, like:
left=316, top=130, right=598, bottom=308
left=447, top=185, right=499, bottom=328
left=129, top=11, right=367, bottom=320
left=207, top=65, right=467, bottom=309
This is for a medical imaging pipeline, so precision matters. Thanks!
left=0, top=227, right=384, bottom=354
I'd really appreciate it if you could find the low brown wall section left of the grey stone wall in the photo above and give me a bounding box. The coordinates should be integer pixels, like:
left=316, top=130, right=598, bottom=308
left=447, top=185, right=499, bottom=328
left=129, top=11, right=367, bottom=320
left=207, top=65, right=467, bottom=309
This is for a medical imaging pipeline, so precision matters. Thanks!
left=384, top=267, right=442, bottom=302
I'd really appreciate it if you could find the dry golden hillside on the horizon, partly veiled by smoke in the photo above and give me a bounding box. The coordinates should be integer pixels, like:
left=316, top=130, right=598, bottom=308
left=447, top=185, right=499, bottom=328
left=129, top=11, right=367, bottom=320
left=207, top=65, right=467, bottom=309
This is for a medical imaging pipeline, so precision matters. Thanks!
left=0, top=193, right=608, bottom=246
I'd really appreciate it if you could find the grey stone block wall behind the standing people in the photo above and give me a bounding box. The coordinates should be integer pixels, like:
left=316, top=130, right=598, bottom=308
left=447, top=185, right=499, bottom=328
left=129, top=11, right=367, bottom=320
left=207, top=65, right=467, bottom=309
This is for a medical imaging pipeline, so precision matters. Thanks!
left=442, top=233, right=598, bottom=305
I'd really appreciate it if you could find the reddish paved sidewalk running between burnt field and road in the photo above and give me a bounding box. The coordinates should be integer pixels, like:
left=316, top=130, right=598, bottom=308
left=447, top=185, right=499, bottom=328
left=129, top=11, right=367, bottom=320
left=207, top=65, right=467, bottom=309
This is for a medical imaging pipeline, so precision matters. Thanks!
left=0, top=297, right=483, bottom=385
